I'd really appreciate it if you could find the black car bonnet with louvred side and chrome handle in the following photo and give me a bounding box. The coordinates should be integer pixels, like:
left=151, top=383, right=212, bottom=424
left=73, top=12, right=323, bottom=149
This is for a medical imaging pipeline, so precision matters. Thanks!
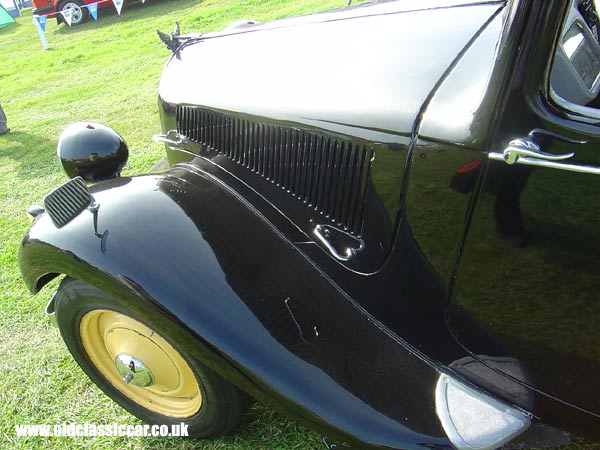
left=159, top=2, right=502, bottom=273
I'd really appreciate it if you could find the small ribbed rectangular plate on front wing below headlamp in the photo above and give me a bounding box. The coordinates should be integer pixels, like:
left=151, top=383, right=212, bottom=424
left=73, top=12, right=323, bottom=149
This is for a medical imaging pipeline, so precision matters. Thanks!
left=44, top=177, right=92, bottom=228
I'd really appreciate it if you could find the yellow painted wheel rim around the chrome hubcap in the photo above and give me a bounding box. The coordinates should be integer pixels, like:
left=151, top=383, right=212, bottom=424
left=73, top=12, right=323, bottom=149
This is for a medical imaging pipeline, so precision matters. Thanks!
left=80, top=309, right=202, bottom=418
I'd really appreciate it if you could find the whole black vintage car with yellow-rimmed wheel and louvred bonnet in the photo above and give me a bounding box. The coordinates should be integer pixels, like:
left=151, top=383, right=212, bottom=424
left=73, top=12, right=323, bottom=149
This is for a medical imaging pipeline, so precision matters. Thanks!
left=19, top=0, right=600, bottom=449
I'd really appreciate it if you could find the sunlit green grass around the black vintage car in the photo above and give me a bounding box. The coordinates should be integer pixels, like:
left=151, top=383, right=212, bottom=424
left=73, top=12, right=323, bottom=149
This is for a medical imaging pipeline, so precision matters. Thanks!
left=0, top=0, right=345, bottom=449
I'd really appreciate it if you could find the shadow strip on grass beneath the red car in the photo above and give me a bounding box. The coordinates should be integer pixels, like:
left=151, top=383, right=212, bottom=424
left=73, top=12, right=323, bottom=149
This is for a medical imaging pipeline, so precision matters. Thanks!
left=55, top=0, right=198, bottom=35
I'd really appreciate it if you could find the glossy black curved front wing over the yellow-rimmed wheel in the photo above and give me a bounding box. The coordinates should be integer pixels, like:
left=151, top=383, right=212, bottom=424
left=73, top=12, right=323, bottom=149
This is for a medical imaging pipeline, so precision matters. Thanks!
left=19, top=165, right=449, bottom=448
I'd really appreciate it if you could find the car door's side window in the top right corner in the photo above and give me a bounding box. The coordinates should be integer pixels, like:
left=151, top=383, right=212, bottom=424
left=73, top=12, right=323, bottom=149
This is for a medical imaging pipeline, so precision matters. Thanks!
left=551, top=0, right=600, bottom=109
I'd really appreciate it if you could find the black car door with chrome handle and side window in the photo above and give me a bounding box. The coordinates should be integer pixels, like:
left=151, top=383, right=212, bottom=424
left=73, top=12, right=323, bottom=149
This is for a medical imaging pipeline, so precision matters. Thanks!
left=449, top=1, right=600, bottom=435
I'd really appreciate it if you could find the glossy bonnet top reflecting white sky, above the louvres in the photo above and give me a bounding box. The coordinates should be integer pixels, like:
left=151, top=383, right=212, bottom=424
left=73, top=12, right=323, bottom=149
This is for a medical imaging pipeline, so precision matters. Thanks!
left=159, top=3, right=501, bottom=142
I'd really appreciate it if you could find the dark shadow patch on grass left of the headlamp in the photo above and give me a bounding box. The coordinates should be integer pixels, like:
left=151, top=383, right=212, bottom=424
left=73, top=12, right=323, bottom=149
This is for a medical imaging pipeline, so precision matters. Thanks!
left=0, top=130, right=56, bottom=179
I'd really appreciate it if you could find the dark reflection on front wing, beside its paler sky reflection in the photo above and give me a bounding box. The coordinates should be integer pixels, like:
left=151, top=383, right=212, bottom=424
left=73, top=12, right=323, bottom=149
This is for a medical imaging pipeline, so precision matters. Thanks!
left=158, top=170, right=450, bottom=436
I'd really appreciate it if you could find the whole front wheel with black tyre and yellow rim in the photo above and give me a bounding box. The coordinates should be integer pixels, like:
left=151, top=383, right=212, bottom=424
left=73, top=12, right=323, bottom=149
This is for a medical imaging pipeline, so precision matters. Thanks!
left=55, top=278, right=250, bottom=437
